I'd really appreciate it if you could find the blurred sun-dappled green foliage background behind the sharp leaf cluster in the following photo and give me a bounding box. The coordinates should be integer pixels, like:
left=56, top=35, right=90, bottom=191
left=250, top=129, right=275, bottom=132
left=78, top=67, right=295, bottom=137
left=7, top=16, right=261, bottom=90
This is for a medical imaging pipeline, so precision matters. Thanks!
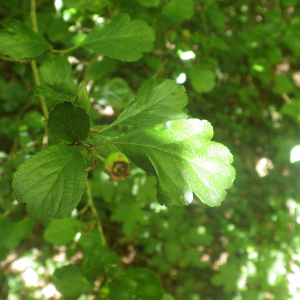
left=0, top=0, right=300, bottom=300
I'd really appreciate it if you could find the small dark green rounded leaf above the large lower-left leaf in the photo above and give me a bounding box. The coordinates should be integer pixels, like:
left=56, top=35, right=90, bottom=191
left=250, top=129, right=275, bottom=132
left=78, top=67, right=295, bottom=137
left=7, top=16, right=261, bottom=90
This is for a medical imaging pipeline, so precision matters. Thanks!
left=48, top=101, right=91, bottom=144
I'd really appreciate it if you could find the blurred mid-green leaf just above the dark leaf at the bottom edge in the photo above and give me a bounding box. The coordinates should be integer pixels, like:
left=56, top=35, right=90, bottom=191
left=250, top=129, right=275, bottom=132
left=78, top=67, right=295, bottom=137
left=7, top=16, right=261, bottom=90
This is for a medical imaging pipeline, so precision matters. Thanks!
left=81, top=245, right=120, bottom=278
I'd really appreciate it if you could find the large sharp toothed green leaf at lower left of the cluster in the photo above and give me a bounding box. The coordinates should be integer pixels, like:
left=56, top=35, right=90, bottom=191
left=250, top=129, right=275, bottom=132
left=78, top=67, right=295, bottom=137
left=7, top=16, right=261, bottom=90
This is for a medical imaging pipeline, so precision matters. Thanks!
left=12, top=145, right=87, bottom=219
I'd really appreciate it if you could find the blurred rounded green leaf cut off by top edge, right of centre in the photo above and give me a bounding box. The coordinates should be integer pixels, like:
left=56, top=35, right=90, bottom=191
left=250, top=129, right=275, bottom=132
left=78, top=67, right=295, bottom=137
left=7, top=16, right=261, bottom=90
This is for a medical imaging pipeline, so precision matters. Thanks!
left=162, top=0, right=194, bottom=23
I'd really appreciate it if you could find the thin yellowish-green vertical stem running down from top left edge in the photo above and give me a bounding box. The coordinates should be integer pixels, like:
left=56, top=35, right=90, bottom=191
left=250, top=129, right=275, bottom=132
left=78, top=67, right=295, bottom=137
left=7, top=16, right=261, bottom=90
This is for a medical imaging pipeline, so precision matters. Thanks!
left=30, top=0, right=49, bottom=149
